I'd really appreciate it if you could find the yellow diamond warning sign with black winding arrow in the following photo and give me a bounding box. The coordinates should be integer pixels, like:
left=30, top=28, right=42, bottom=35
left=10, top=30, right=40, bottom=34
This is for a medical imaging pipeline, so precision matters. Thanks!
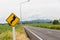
left=6, top=13, right=20, bottom=26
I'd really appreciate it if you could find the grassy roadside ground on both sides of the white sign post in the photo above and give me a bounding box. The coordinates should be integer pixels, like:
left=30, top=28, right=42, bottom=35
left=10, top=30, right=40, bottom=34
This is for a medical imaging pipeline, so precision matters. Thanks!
left=0, top=24, right=29, bottom=40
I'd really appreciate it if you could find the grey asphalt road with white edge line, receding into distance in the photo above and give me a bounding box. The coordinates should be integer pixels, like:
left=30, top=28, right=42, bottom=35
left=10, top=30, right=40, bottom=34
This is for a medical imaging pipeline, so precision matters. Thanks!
left=24, top=26, right=60, bottom=40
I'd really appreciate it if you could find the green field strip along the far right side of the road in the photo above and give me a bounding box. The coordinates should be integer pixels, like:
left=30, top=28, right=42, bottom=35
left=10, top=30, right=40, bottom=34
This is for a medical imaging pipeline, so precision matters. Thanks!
left=28, top=23, right=60, bottom=30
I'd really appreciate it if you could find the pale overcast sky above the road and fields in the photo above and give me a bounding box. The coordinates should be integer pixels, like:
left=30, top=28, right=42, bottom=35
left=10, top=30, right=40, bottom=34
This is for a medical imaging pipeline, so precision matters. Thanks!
left=0, top=0, right=60, bottom=22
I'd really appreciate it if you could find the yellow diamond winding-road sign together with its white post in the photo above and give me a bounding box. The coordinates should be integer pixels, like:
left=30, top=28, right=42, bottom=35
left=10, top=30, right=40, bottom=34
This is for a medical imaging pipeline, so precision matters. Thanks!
left=6, top=13, right=20, bottom=40
